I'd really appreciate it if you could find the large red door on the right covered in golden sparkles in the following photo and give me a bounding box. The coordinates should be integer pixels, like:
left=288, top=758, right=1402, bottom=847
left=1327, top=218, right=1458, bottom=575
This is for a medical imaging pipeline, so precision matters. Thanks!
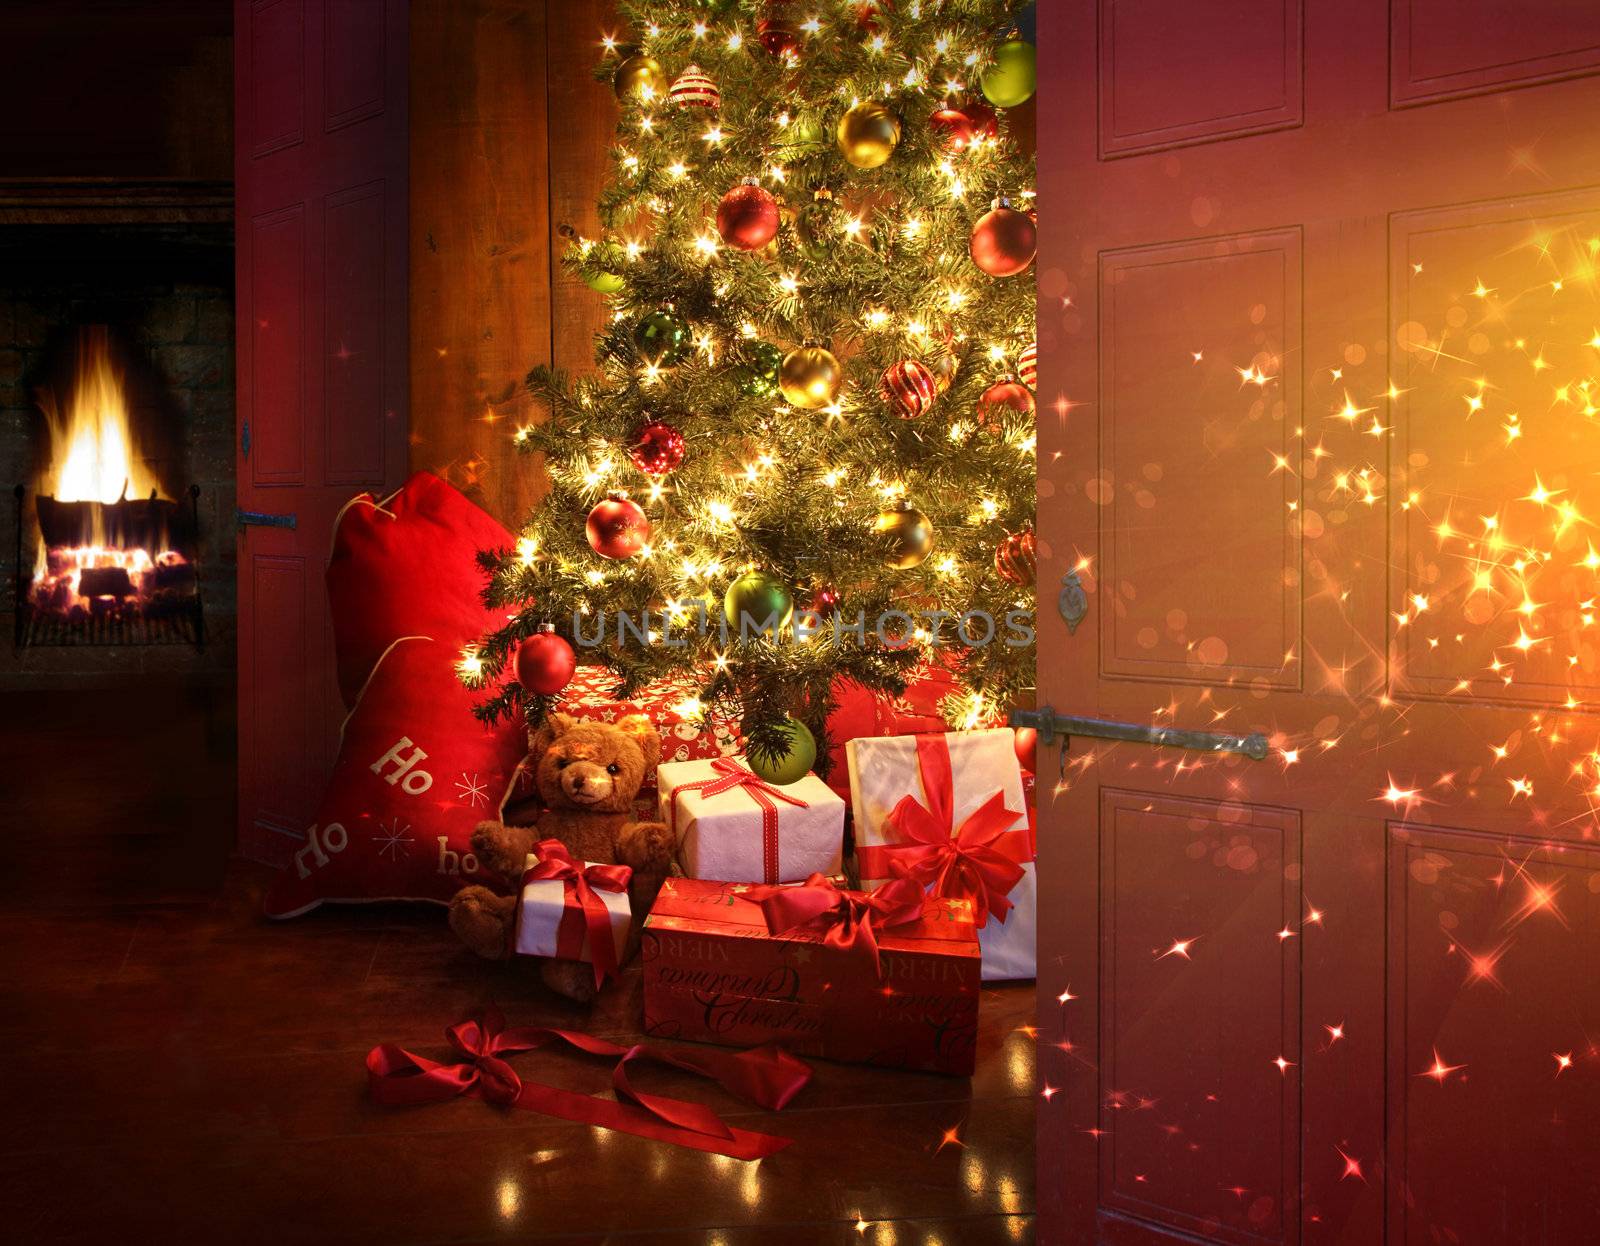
left=1038, top=0, right=1600, bottom=1243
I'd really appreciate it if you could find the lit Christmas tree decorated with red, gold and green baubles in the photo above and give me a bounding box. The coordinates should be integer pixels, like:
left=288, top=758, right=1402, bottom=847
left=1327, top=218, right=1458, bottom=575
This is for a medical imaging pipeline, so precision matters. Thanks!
left=464, top=0, right=1035, bottom=774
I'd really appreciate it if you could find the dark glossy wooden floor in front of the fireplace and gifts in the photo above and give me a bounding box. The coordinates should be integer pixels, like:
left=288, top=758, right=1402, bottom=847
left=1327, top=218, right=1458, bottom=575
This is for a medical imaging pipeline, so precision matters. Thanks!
left=0, top=681, right=1034, bottom=1246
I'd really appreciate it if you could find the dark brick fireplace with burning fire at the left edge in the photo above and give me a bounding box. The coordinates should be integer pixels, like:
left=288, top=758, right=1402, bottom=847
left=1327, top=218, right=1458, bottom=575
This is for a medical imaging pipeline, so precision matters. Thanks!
left=0, top=181, right=235, bottom=686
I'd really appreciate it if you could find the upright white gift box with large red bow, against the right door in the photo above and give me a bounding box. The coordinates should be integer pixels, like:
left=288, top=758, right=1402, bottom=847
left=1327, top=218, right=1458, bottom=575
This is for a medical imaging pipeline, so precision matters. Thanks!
left=845, top=728, right=1038, bottom=982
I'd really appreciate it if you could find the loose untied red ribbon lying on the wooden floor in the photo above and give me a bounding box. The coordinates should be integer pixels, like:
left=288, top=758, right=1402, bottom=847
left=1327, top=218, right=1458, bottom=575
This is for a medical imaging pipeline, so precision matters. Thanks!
left=366, top=1008, right=811, bottom=1160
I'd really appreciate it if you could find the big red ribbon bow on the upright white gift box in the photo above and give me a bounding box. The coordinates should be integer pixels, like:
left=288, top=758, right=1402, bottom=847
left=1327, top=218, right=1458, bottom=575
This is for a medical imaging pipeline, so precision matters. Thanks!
left=858, top=734, right=1034, bottom=926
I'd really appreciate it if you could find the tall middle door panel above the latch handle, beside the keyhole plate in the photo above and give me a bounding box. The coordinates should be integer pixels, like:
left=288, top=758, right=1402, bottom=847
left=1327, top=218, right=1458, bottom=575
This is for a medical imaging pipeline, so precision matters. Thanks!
left=1090, top=230, right=1301, bottom=688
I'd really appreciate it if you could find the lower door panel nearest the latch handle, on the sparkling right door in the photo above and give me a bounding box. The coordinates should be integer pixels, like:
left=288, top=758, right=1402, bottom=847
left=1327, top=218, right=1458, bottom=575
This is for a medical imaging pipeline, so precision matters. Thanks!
left=1099, top=787, right=1301, bottom=1243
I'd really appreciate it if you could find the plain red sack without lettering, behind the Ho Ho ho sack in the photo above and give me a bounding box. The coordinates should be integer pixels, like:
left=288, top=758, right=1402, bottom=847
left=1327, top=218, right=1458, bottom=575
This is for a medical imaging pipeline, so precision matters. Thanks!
left=328, top=472, right=515, bottom=705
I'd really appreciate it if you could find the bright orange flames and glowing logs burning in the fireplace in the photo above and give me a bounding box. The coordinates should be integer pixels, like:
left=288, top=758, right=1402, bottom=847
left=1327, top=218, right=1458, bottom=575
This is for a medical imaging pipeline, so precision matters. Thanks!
left=32, top=326, right=187, bottom=611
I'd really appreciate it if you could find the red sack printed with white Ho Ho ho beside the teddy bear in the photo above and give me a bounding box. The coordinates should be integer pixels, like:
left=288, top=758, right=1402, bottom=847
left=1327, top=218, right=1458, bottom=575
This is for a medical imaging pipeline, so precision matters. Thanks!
left=266, top=637, right=526, bottom=917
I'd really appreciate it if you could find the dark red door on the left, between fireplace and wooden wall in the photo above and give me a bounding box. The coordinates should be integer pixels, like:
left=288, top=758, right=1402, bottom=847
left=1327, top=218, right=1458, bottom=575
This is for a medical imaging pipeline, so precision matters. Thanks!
left=234, top=0, right=408, bottom=862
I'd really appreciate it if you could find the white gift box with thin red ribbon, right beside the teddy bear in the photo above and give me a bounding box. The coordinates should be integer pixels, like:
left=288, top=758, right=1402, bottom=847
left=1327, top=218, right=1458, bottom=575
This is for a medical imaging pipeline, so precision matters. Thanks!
left=656, top=757, right=845, bottom=883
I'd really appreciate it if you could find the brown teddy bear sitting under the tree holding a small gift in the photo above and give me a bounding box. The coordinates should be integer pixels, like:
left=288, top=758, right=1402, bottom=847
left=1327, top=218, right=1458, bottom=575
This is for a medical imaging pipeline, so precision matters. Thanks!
left=450, top=713, right=675, bottom=1003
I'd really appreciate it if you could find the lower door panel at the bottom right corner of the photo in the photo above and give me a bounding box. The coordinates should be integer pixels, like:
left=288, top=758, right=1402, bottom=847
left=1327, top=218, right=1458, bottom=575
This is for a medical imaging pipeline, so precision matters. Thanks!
left=1389, top=822, right=1600, bottom=1243
